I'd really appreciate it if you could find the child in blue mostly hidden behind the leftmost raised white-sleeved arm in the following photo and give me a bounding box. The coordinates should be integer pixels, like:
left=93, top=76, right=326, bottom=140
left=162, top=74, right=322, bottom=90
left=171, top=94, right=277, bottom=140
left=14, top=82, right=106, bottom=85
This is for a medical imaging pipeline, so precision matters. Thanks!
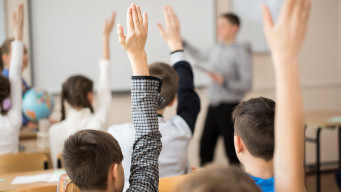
left=0, top=38, right=30, bottom=128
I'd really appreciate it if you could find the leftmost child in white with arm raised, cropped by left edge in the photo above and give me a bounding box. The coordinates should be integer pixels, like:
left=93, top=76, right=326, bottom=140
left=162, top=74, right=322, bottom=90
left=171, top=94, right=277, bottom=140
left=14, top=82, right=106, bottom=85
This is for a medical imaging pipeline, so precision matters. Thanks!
left=0, top=4, right=24, bottom=155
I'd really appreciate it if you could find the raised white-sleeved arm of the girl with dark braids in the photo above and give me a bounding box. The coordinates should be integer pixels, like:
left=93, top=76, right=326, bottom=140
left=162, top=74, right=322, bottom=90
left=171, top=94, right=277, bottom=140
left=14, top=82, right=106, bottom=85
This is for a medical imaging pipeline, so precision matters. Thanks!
left=95, top=12, right=116, bottom=129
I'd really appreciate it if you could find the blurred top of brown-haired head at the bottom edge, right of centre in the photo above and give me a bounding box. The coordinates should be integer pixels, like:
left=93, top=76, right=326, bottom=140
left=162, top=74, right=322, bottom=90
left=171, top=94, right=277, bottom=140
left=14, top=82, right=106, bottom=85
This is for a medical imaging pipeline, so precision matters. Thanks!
left=175, top=165, right=260, bottom=192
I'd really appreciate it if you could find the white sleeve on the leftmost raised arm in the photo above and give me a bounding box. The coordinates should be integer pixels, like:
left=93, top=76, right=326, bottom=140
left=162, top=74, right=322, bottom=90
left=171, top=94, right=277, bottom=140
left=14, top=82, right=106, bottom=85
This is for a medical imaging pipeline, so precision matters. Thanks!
left=8, top=41, right=24, bottom=128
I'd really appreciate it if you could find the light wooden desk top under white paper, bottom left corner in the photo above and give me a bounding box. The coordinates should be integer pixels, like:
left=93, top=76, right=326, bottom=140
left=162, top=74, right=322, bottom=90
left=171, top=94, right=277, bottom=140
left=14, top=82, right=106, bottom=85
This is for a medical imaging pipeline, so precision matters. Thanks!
left=0, top=170, right=58, bottom=191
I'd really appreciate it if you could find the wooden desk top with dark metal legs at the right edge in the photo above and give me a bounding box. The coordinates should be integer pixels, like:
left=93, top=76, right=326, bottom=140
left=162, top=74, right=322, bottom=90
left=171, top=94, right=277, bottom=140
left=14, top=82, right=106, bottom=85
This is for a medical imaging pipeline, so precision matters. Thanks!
left=304, top=110, right=341, bottom=127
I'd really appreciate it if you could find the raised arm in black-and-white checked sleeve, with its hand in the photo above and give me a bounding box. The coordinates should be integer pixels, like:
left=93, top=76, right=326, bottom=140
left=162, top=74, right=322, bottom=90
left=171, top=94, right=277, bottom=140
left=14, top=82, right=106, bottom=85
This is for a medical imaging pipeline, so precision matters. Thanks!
left=118, top=4, right=162, bottom=191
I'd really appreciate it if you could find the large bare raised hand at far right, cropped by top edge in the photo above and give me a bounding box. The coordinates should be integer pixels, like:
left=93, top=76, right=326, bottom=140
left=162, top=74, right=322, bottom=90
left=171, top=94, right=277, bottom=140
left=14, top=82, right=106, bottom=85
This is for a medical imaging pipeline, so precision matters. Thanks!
left=262, top=0, right=311, bottom=63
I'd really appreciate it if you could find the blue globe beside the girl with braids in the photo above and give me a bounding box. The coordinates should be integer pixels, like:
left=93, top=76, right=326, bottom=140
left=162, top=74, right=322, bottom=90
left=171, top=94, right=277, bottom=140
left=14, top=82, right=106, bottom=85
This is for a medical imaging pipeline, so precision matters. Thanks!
left=22, top=88, right=54, bottom=121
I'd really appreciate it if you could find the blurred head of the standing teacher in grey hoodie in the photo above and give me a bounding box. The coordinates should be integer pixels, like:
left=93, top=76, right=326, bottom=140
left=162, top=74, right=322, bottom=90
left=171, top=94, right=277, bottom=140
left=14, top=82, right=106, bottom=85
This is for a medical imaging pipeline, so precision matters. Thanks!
left=217, top=13, right=240, bottom=41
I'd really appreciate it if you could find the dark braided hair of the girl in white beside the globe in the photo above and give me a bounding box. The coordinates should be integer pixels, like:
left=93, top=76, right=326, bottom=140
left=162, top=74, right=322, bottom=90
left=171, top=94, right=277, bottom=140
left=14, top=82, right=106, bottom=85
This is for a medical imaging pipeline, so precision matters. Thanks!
left=61, top=75, right=94, bottom=120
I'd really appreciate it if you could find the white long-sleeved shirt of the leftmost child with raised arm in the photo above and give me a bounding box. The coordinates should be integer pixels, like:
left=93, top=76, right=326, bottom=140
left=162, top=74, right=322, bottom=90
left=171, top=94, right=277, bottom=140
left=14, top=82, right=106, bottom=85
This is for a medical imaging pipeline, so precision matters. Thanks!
left=0, top=41, right=24, bottom=155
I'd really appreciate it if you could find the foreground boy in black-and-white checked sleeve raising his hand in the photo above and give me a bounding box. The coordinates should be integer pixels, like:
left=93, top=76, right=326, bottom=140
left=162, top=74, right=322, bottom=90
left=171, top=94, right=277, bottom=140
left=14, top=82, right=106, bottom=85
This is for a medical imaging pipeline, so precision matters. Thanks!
left=59, top=4, right=164, bottom=192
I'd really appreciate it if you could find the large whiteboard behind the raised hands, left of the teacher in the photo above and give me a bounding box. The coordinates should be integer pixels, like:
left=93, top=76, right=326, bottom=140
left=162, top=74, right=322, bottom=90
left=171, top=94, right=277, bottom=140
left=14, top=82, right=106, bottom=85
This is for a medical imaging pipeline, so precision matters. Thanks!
left=30, top=0, right=215, bottom=92
